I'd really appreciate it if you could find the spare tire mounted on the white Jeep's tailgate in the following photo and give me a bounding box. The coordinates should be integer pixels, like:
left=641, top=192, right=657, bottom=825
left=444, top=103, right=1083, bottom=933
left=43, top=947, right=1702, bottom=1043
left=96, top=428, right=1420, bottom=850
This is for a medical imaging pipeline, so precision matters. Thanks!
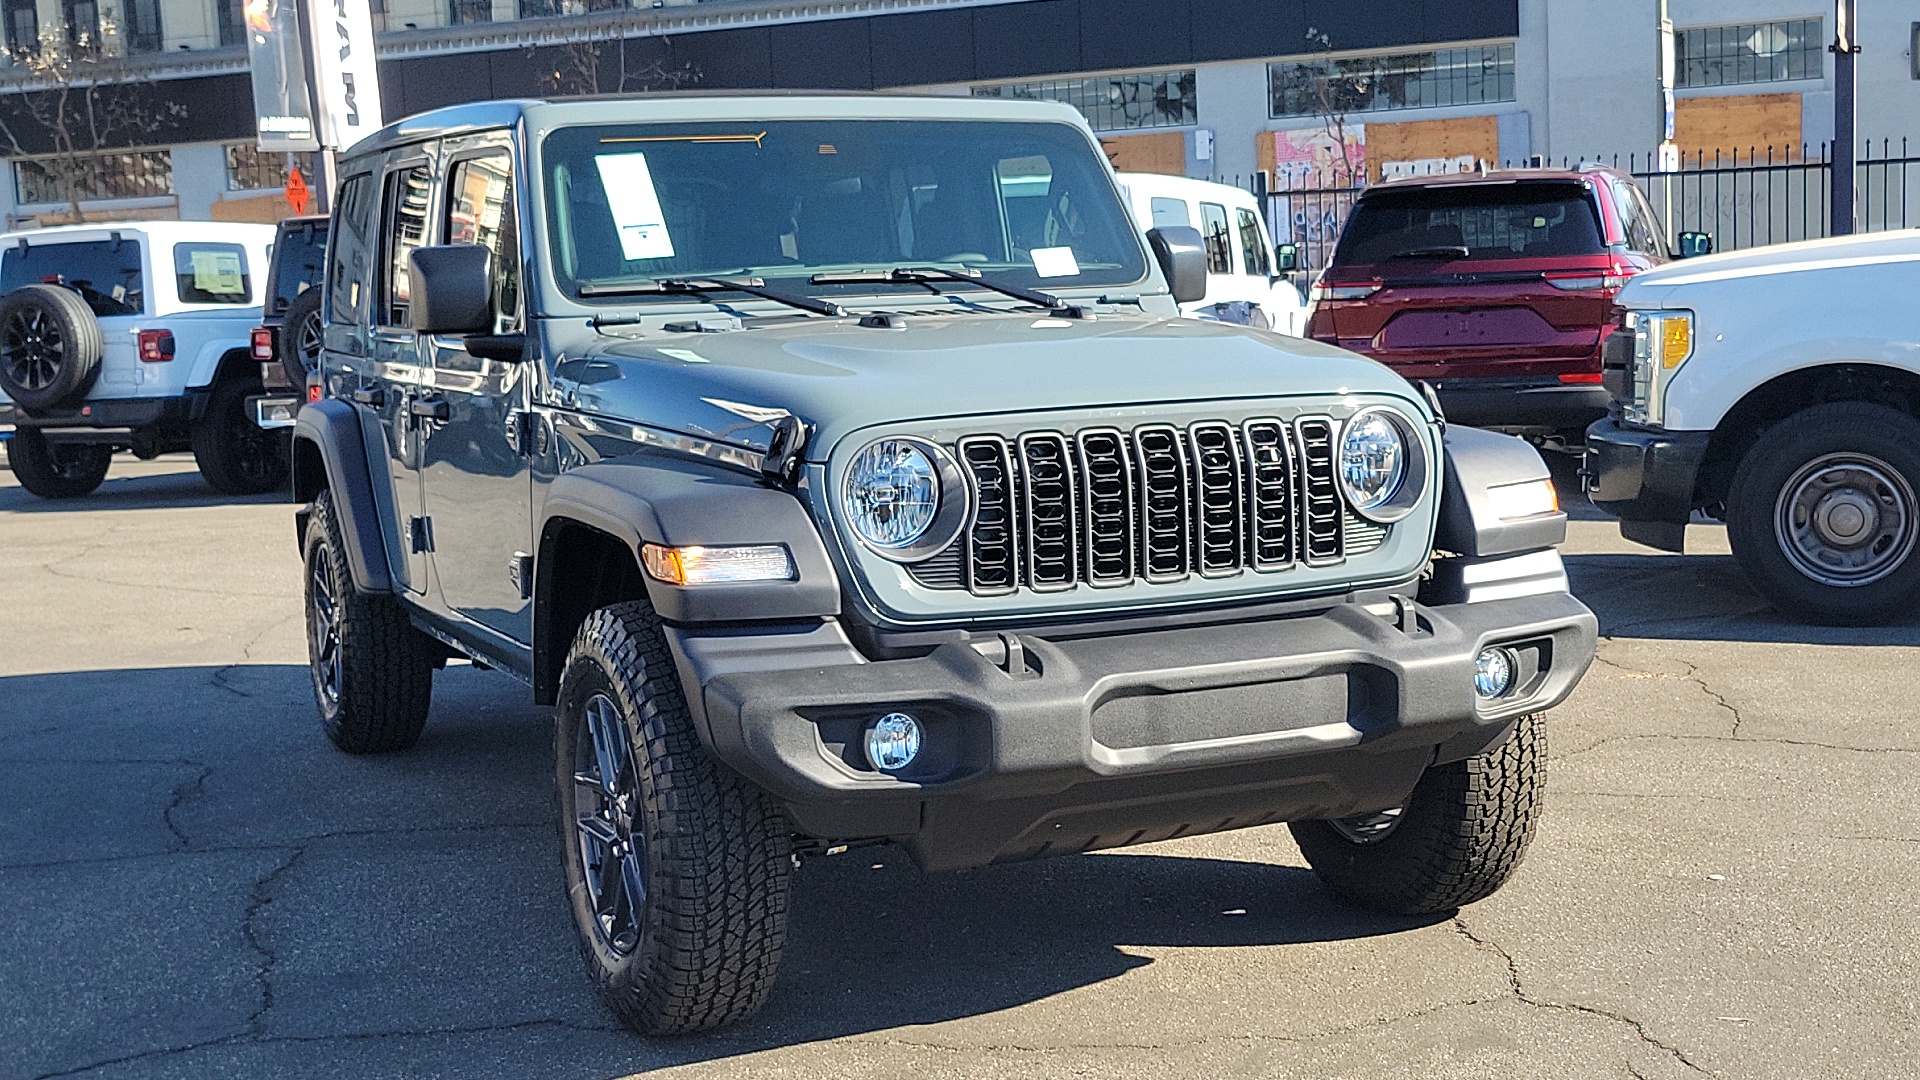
left=0, top=284, right=102, bottom=409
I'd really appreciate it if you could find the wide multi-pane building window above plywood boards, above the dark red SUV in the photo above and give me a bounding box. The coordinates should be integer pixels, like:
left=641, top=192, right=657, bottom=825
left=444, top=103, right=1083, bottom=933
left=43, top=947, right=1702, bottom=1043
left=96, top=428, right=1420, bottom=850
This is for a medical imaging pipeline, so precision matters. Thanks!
left=1267, top=44, right=1513, bottom=117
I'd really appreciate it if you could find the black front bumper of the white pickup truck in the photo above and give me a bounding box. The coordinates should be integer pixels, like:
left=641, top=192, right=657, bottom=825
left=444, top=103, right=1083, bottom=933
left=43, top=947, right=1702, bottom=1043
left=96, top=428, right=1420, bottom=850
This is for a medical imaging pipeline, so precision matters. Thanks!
left=1584, top=417, right=1711, bottom=552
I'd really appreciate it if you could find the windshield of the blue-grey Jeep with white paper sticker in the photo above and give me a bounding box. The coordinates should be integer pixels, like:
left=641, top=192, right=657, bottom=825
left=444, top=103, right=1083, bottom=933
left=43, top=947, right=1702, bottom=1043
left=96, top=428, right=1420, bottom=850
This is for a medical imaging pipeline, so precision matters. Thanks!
left=541, top=121, right=1146, bottom=304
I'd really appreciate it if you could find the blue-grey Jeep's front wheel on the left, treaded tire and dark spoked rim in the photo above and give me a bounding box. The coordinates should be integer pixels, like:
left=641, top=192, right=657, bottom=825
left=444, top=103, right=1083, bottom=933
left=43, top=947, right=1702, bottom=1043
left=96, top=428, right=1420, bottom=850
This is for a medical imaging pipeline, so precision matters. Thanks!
left=555, top=601, right=793, bottom=1034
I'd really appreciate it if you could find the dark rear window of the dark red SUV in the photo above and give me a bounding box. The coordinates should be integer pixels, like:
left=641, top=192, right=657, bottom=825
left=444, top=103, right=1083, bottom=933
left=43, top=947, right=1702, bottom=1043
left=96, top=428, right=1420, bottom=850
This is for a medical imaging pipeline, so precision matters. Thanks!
left=1332, top=183, right=1607, bottom=269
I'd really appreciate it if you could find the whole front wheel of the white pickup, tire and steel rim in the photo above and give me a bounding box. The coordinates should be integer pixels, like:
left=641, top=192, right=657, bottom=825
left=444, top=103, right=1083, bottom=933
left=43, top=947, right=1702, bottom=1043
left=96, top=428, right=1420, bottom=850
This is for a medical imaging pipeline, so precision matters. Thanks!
left=1726, top=402, right=1920, bottom=625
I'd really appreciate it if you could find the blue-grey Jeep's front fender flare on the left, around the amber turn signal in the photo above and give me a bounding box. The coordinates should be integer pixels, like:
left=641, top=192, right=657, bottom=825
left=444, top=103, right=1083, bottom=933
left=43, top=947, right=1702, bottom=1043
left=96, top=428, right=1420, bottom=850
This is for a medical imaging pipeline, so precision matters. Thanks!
left=534, top=455, right=841, bottom=622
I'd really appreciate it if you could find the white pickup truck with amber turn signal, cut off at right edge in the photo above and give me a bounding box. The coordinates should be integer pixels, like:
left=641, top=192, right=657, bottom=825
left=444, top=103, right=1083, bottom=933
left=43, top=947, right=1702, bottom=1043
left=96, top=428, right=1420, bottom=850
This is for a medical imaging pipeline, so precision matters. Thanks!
left=1586, top=231, right=1920, bottom=625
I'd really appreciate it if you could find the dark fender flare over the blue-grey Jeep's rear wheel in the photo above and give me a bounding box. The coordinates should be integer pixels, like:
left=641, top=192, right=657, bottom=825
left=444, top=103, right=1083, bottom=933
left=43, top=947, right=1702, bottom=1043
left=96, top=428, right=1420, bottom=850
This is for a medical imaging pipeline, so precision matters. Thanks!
left=294, top=398, right=394, bottom=592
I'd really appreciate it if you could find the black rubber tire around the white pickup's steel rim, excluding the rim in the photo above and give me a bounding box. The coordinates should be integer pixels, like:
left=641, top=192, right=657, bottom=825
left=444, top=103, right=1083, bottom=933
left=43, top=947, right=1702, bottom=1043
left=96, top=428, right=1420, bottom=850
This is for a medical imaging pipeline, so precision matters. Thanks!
left=1726, top=402, right=1920, bottom=626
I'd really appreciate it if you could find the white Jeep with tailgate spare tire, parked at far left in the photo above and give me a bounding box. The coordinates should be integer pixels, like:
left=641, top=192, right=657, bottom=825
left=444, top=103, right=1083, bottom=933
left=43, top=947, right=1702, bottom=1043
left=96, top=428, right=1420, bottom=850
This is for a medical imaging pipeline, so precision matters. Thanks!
left=0, top=221, right=286, bottom=498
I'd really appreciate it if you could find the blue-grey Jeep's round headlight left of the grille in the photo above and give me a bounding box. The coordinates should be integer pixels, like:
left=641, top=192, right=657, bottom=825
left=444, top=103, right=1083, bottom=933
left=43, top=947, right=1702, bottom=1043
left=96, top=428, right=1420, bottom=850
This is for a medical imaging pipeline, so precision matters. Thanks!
left=839, top=436, right=972, bottom=563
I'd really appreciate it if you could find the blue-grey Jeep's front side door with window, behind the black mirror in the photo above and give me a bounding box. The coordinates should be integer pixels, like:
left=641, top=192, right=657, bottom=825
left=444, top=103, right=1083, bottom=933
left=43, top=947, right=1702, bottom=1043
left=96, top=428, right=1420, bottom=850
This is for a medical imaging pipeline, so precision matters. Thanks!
left=420, top=143, right=534, bottom=644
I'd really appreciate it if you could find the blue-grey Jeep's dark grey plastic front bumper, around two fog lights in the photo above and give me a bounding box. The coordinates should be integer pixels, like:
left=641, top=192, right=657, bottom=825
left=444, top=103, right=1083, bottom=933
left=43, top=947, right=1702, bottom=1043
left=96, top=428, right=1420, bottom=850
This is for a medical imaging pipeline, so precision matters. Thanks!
left=672, top=592, right=1596, bottom=869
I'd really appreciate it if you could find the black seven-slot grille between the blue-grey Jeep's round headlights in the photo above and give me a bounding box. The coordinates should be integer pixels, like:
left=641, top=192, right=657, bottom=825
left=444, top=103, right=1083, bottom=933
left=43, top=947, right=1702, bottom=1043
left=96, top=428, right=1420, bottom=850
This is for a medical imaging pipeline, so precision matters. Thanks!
left=940, top=417, right=1386, bottom=596
